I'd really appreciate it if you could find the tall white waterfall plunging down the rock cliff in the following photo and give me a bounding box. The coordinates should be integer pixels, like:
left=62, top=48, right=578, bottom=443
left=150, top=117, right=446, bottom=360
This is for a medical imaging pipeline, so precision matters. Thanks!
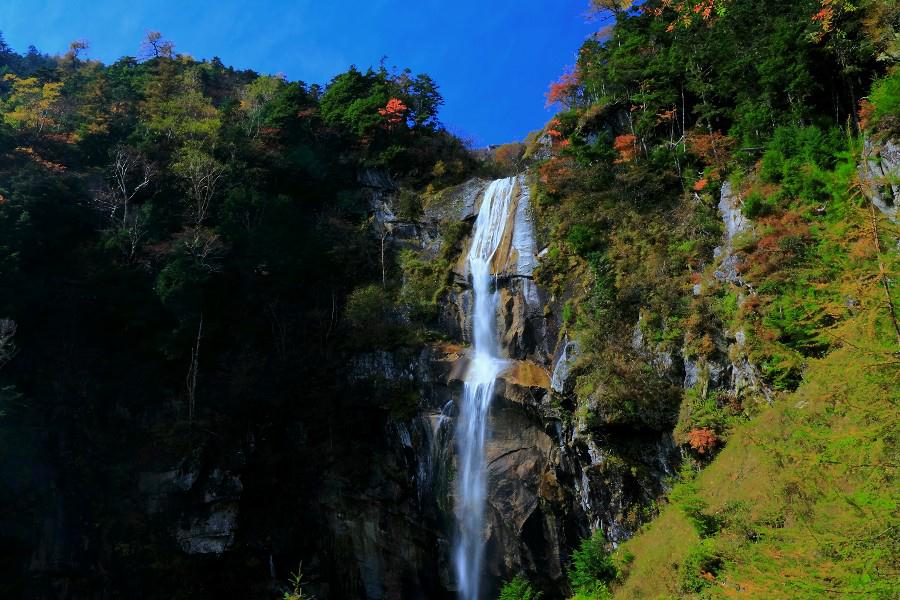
left=454, top=177, right=516, bottom=600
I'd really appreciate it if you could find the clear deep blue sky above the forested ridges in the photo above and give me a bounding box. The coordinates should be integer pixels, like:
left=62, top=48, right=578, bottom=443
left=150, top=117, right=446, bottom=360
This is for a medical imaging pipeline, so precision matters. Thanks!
left=0, top=0, right=596, bottom=145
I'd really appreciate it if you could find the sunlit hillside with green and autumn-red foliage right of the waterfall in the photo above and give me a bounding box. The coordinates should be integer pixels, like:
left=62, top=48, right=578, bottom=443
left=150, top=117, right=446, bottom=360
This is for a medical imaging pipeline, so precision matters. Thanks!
left=502, top=0, right=900, bottom=598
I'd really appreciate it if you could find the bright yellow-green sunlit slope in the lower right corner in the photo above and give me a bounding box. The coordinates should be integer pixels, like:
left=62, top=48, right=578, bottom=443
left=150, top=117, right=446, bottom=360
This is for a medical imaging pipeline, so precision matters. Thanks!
left=614, top=191, right=900, bottom=598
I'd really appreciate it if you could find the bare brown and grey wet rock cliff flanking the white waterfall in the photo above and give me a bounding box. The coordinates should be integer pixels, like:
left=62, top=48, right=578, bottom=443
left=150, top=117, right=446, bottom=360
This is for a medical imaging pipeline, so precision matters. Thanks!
left=310, top=171, right=704, bottom=600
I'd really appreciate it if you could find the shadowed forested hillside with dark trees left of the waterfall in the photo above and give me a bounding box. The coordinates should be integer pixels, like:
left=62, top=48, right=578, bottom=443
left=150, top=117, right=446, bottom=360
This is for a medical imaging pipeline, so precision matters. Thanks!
left=0, top=33, right=476, bottom=598
